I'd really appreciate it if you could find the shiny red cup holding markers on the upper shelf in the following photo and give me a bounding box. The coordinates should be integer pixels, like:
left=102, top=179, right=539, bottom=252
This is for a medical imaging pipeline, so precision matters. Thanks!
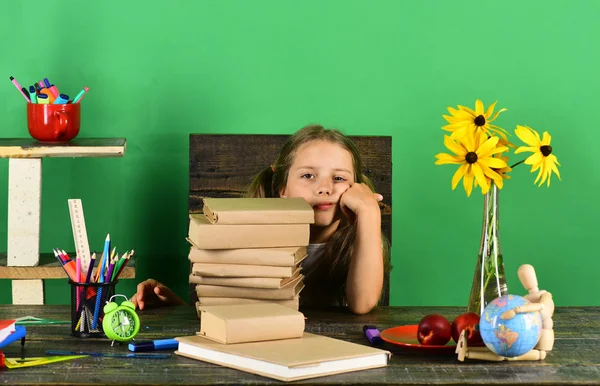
left=27, top=103, right=81, bottom=142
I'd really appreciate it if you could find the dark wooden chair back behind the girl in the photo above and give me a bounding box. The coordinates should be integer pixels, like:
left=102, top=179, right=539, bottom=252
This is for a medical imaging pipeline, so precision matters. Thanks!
left=188, top=134, right=393, bottom=305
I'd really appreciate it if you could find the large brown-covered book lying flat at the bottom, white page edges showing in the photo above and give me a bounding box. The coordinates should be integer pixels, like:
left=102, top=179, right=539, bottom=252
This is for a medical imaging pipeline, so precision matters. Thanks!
left=175, top=332, right=392, bottom=382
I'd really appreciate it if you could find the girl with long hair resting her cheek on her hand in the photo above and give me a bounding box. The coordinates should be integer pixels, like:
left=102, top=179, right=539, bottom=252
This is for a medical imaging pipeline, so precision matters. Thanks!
left=132, top=125, right=389, bottom=314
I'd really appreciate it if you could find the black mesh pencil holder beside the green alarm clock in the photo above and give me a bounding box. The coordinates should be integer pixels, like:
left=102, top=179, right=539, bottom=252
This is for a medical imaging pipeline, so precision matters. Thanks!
left=69, top=280, right=118, bottom=338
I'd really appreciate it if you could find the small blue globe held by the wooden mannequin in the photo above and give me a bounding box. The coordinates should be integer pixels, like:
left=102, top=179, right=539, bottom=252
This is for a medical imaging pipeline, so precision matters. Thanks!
left=479, top=295, right=542, bottom=358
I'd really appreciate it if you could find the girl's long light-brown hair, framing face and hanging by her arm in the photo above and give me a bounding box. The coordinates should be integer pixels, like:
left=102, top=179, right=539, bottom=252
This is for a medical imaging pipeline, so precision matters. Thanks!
left=248, top=125, right=391, bottom=306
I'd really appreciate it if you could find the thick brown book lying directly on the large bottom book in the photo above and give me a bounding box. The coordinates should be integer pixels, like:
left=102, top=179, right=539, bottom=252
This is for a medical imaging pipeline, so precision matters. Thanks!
left=197, top=303, right=304, bottom=344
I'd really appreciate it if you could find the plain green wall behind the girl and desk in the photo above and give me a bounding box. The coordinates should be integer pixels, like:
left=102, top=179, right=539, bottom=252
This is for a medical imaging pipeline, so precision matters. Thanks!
left=0, top=0, right=600, bottom=306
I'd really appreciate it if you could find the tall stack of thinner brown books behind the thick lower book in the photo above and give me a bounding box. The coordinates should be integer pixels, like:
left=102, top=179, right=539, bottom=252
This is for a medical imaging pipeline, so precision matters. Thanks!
left=188, top=198, right=314, bottom=310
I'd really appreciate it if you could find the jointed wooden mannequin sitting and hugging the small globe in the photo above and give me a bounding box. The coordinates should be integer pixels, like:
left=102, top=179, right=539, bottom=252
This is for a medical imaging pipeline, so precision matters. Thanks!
left=455, top=264, right=554, bottom=362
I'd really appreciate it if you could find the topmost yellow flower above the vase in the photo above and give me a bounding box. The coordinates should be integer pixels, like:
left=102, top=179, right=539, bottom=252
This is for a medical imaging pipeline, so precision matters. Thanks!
left=442, top=99, right=508, bottom=139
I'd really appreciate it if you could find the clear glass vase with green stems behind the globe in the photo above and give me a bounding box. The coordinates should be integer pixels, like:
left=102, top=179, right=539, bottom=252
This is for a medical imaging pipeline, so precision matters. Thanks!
left=467, top=182, right=508, bottom=315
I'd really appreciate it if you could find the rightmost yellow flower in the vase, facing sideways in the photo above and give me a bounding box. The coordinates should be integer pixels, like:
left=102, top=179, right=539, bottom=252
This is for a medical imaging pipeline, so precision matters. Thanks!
left=515, top=125, right=560, bottom=186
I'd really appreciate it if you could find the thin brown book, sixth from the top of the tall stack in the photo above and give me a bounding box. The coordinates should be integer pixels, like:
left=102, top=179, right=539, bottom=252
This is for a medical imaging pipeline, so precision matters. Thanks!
left=196, top=274, right=304, bottom=300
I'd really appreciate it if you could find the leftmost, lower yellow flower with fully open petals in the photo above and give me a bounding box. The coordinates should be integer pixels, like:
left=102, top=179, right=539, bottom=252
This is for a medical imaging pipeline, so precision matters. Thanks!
left=435, top=131, right=508, bottom=196
